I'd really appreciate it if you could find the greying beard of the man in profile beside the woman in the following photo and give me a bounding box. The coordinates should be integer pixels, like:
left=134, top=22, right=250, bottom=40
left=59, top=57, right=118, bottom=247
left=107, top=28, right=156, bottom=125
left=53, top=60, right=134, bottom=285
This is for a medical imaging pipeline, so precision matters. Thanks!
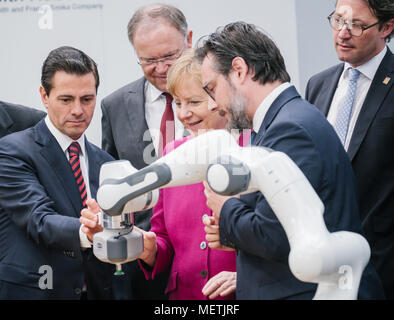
left=226, top=91, right=253, bottom=131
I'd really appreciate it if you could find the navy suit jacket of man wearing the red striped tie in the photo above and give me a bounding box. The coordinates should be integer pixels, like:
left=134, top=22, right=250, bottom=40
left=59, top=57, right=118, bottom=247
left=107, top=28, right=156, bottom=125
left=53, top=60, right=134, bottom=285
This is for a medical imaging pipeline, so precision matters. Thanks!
left=0, top=120, right=114, bottom=299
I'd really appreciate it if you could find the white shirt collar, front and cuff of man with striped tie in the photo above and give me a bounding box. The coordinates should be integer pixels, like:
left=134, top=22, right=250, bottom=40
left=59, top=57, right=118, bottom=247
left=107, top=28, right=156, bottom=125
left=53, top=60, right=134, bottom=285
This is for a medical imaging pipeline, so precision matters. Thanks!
left=45, top=115, right=92, bottom=248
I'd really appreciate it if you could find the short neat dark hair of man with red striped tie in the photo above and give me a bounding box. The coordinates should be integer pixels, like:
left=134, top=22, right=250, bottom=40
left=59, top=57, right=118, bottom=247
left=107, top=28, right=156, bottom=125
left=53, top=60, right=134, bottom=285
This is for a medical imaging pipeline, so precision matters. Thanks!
left=41, top=46, right=100, bottom=95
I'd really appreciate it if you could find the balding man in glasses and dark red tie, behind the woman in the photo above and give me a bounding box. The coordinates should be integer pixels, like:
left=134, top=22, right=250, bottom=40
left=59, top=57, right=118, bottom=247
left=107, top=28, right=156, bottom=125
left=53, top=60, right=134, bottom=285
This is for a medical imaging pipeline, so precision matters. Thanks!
left=101, top=4, right=192, bottom=299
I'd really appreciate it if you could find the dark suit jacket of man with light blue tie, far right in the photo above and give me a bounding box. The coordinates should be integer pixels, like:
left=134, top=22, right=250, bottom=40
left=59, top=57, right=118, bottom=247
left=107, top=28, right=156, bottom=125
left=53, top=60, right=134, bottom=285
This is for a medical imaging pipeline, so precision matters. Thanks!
left=306, top=50, right=394, bottom=299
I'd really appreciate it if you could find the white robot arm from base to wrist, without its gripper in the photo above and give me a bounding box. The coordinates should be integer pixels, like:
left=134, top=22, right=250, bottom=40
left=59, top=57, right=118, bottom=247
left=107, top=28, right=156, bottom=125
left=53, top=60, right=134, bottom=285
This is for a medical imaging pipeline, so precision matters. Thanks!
left=95, top=130, right=370, bottom=299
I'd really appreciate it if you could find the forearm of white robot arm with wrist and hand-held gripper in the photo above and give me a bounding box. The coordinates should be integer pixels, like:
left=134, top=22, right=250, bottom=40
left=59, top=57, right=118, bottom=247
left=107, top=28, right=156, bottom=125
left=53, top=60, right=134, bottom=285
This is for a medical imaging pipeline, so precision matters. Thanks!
left=93, top=131, right=237, bottom=274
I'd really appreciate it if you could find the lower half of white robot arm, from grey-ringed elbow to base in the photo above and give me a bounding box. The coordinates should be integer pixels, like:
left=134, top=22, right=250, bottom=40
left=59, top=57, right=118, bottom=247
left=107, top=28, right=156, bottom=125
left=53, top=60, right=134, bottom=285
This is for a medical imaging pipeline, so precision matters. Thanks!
left=207, top=142, right=370, bottom=300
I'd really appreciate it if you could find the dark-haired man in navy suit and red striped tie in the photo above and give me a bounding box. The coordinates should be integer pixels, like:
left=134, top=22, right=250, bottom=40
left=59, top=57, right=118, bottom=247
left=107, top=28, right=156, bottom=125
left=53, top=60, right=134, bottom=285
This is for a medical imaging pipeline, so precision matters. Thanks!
left=0, top=47, right=114, bottom=299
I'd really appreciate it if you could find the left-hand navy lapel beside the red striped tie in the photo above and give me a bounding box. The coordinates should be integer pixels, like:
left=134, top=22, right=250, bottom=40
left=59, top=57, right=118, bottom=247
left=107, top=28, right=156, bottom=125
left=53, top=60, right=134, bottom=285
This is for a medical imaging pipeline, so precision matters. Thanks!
left=35, top=120, right=82, bottom=217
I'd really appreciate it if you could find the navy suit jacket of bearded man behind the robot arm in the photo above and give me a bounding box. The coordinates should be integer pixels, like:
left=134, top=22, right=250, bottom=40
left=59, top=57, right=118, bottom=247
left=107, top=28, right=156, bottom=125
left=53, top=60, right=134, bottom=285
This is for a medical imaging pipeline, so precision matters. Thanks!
left=219, top=87, right=381, bottom=299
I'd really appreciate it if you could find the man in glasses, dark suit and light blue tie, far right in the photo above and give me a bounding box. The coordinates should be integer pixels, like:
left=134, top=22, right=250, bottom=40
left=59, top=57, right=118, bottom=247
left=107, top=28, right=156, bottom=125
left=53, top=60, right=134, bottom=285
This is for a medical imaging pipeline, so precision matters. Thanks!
left=306, top=0, right=394, bottom=299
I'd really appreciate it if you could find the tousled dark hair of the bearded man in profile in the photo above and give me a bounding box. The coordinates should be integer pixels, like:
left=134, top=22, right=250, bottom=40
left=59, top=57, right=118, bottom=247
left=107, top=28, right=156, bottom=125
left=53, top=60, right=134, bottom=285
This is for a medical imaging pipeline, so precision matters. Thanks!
left=196, top=22, right=290, bottom=84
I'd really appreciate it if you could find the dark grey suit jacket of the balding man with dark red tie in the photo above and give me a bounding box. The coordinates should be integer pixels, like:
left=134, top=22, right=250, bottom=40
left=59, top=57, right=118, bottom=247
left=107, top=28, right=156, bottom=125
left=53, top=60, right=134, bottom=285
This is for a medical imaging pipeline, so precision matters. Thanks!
left=101, top=77, right=169, bottom=299
